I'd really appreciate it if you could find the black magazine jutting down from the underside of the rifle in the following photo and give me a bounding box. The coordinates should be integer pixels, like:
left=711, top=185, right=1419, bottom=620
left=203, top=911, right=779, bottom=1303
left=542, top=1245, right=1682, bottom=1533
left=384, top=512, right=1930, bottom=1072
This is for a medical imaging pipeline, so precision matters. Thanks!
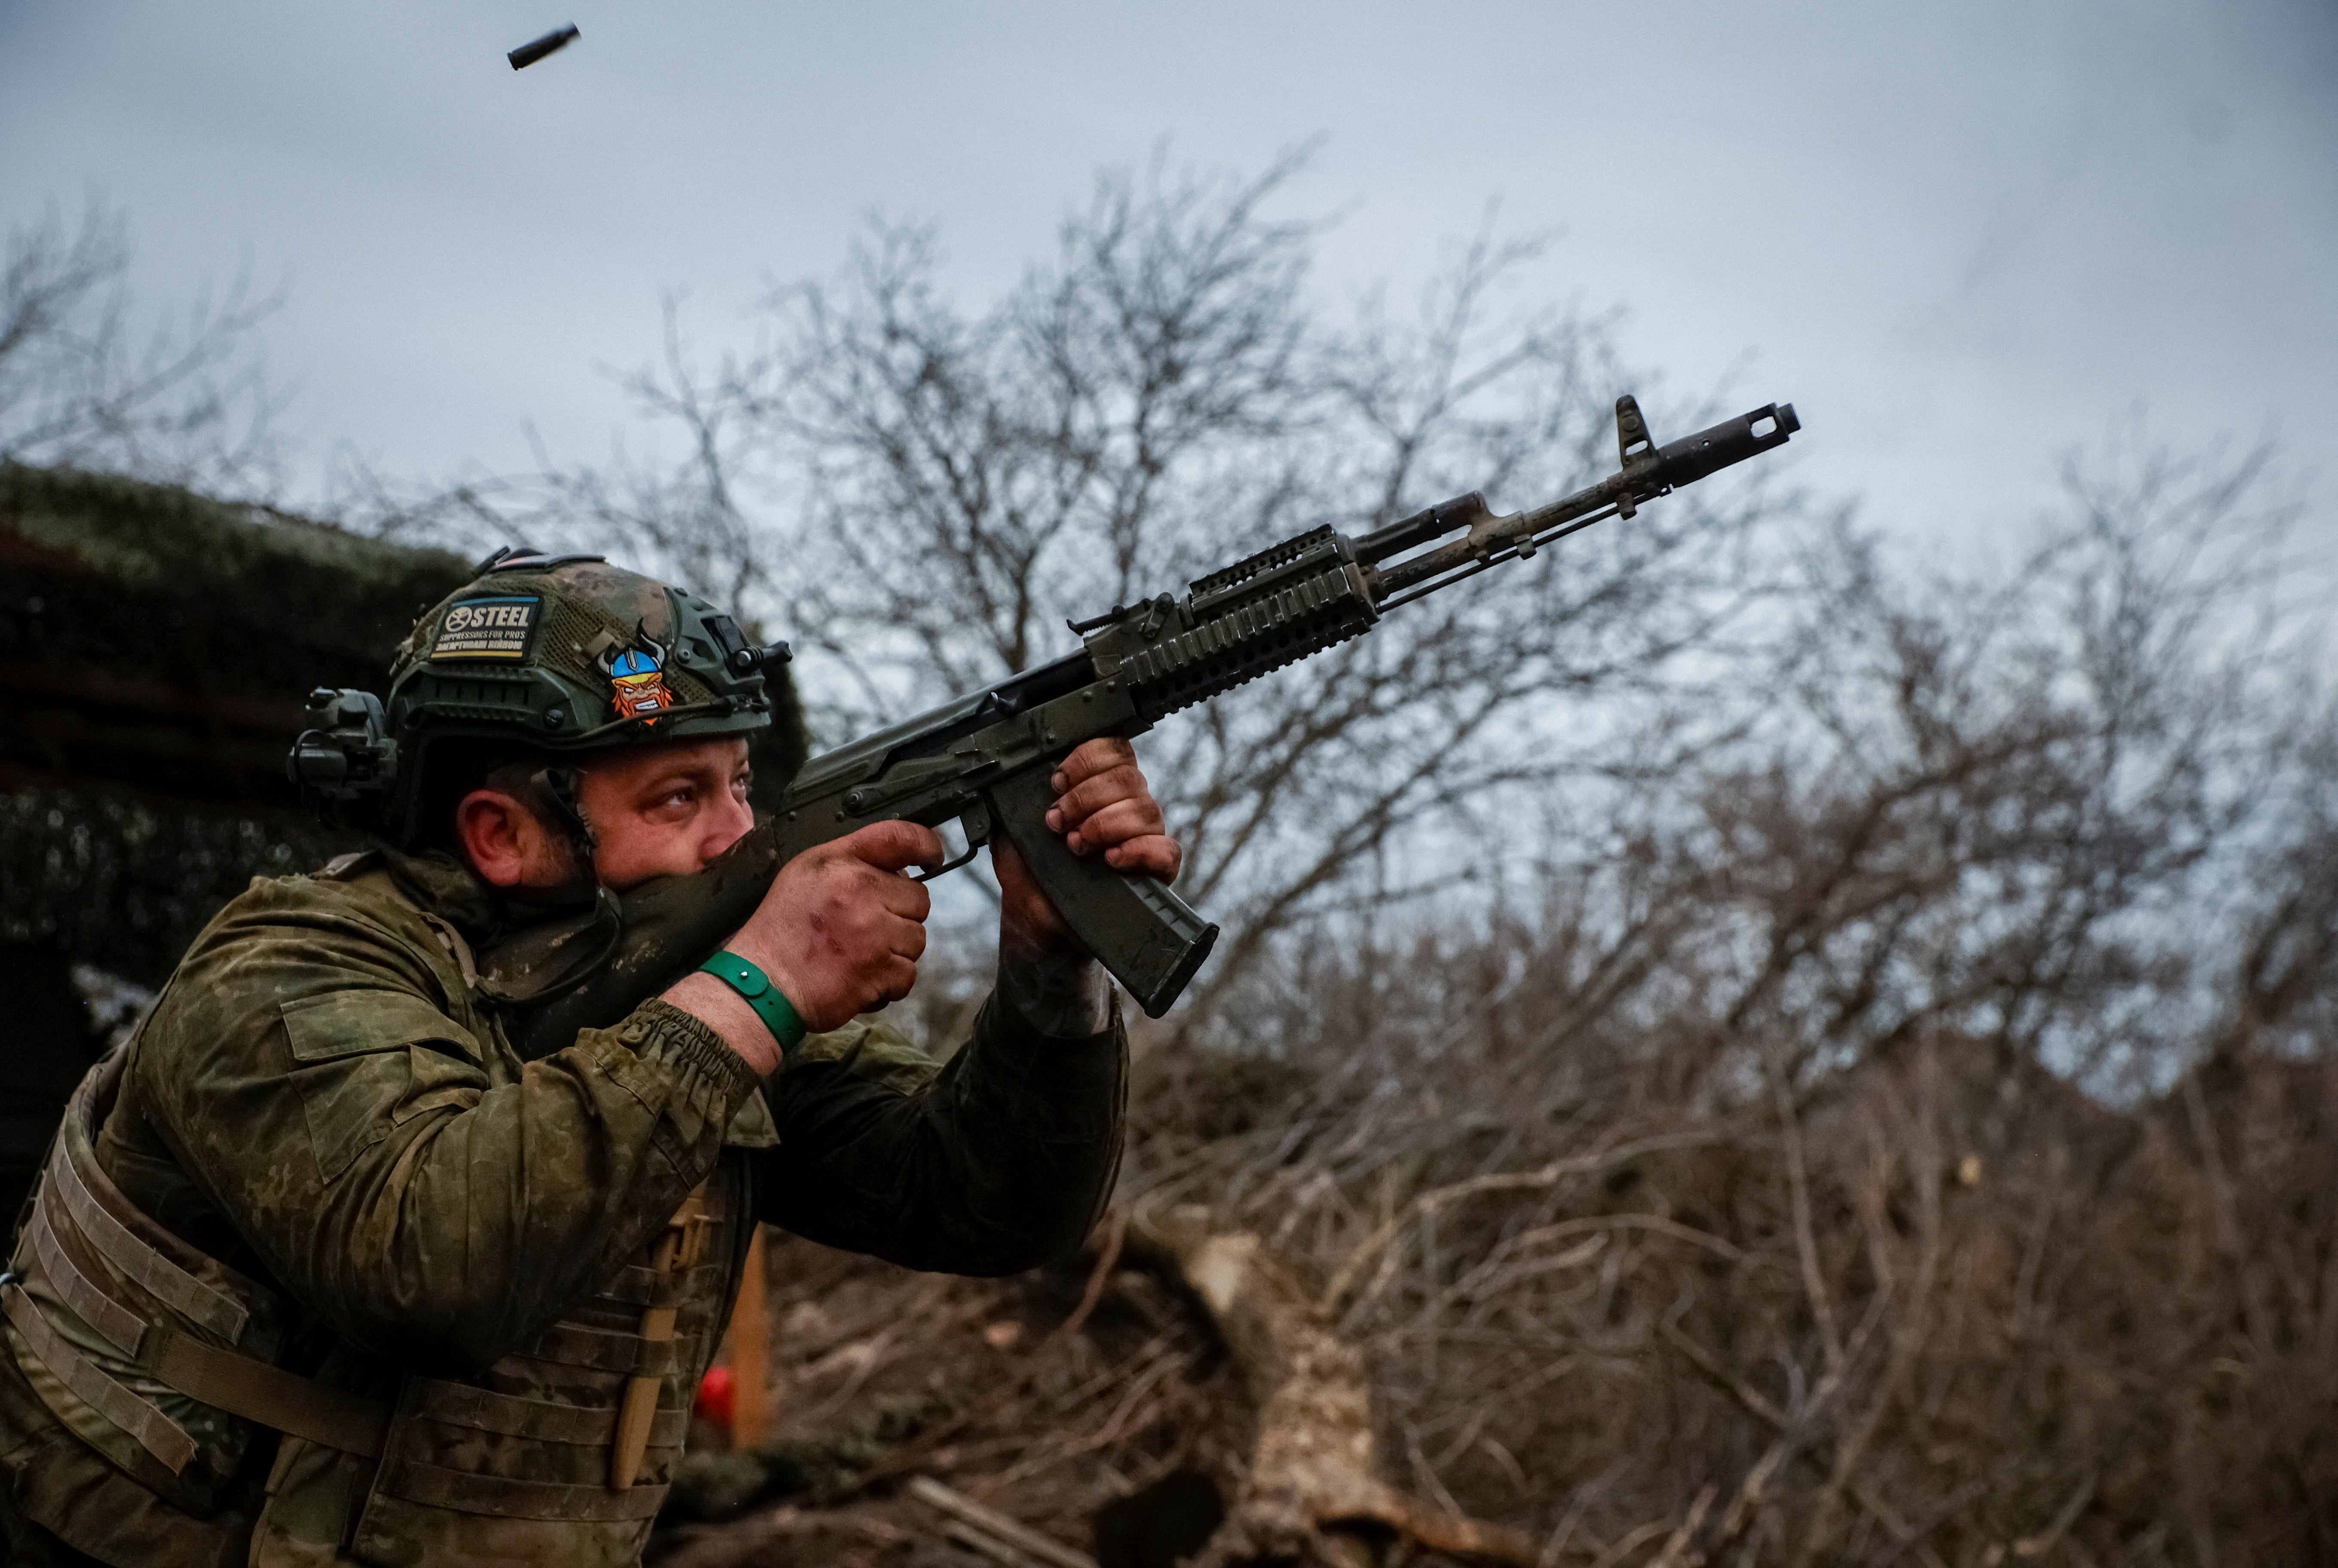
left=987, top=766, right=1218, bottom=1019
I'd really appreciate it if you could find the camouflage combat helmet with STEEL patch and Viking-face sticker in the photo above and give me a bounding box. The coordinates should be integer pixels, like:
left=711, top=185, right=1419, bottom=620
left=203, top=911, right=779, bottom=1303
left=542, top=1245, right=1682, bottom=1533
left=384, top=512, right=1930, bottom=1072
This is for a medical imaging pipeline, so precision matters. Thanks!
left=285, top=547, right=788, bottom=846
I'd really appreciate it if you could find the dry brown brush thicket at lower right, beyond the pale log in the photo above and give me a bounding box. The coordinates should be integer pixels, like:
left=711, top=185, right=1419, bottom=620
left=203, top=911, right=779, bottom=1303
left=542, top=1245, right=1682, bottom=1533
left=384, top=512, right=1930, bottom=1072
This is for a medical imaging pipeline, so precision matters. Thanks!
left=1141, top=1014, right=2338, bottom=1563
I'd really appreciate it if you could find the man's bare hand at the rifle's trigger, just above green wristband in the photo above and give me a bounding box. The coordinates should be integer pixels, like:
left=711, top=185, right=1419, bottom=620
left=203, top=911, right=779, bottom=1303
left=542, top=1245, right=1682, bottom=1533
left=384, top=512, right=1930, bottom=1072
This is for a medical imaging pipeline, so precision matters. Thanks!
left=727, top=823, right=944, bottom=1031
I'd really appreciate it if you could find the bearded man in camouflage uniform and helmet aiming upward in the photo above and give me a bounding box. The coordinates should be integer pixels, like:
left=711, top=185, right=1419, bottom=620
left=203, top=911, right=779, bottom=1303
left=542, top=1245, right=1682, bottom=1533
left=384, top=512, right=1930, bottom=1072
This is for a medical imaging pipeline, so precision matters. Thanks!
left=0, top=551, right=1178, bottom=1568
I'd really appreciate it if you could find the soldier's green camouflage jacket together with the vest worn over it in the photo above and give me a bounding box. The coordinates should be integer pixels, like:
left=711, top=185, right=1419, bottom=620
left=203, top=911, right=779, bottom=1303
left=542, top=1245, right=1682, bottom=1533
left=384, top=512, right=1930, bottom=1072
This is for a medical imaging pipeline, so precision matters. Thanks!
left=0, top=860, right=1127, bottom=1566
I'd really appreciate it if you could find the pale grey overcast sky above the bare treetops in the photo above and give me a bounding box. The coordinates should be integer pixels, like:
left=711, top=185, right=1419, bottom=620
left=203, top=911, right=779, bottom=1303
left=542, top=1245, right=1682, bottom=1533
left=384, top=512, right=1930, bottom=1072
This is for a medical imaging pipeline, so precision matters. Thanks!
left=0, top=0, right=2338, bottom=565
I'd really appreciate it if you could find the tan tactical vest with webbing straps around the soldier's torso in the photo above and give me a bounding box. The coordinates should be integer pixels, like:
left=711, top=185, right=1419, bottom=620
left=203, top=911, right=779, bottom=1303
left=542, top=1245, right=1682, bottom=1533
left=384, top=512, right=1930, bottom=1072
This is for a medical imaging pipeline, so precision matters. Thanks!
left=0, top=883, right=760, bottom=1568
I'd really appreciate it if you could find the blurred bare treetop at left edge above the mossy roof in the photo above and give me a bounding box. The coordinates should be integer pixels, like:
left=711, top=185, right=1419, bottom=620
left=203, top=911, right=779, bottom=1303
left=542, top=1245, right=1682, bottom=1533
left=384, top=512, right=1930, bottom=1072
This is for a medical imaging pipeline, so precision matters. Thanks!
left=0, top=201, right=281, bottom=500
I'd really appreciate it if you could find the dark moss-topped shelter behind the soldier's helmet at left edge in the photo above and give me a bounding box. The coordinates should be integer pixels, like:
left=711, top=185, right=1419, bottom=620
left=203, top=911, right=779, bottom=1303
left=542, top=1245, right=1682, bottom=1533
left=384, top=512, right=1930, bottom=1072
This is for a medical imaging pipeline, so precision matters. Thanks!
left=0, top=465, right=465, bottom=984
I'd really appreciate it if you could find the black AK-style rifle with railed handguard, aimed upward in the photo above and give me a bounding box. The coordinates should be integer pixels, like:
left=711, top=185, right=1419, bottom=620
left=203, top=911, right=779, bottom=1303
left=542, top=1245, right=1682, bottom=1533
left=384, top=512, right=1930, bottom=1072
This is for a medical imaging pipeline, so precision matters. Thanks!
left=486, top=397, right=1800, bottom=1056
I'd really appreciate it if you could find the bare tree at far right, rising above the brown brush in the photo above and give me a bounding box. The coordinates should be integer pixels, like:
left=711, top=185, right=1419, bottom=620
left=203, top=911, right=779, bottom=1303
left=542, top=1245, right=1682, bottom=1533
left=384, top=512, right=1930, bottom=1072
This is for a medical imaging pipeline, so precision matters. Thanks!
left=1704, top=435, right=2312, bottom=1098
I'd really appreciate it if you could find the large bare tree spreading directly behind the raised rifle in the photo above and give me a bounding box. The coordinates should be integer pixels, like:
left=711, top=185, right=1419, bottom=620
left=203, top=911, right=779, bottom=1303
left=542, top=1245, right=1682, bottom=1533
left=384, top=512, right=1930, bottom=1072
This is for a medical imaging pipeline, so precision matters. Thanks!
left=425, top=159, right=1793, bottom=1014
